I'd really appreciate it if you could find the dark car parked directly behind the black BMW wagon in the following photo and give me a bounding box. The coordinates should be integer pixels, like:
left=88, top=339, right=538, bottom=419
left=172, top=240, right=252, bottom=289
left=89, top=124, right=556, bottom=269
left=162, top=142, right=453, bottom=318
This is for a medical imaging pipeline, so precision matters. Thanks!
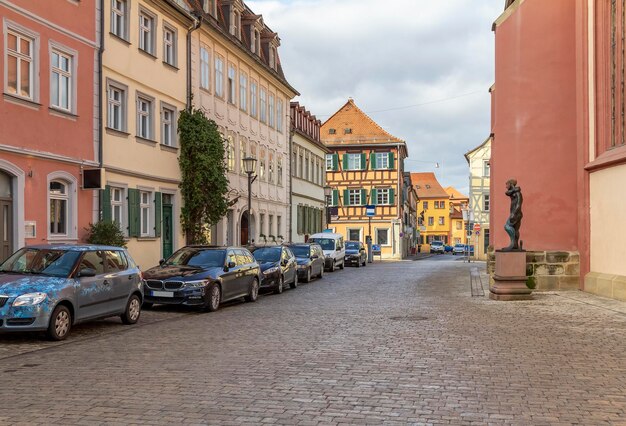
left=252, top=246, right=298, bottom=294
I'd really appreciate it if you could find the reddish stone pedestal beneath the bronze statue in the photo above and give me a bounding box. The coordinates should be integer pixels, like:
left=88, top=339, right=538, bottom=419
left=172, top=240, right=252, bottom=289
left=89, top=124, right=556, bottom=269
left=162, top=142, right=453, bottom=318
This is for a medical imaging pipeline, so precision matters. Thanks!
left=489, top=250, right=533, bottom=300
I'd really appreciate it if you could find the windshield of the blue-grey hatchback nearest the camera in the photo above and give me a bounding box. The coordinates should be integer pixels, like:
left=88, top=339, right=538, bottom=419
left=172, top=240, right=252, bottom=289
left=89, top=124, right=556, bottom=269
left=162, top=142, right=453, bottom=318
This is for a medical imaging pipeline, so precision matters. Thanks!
left=0, top=247, right=80, bottom=278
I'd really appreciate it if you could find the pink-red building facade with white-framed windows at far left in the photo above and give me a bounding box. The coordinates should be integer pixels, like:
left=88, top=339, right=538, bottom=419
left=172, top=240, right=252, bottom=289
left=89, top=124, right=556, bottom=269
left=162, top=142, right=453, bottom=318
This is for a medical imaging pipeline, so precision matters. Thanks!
left=0, top=0, right=99, bottom=260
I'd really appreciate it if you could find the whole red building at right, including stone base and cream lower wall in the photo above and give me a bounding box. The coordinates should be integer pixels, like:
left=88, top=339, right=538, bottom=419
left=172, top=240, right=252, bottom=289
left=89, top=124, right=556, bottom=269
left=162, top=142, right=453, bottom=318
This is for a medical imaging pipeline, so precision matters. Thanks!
left=490, top=0, right=626, bottom=300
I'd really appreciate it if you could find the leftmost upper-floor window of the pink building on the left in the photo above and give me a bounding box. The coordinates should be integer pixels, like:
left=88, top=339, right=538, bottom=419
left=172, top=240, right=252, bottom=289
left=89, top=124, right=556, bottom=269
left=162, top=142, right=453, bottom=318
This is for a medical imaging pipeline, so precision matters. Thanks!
left=5, top=29, right=35, bottom=100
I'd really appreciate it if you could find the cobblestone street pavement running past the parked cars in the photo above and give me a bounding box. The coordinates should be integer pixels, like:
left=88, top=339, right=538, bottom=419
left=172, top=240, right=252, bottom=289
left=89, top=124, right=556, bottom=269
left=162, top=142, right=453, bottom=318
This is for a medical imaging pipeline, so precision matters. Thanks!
left=0, top=258, right=626, bottom=425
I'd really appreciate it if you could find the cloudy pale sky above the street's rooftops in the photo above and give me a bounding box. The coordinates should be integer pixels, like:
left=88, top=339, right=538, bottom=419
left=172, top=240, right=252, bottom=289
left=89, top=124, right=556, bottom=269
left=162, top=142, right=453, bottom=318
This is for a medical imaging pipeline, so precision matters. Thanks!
left=245, top=0, right=504, bottom=194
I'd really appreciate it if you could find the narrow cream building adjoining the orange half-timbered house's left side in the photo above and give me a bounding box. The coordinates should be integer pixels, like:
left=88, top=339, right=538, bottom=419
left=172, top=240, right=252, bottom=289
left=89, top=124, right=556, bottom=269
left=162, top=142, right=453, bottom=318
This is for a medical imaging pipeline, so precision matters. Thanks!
left=288, top=102, right=330, bottom=242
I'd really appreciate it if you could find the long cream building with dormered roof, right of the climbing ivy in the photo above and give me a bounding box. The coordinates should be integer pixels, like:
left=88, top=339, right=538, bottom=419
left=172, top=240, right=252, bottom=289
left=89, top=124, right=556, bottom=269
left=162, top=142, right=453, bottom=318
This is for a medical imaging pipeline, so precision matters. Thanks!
left=191, top=0, right=298, bottom=245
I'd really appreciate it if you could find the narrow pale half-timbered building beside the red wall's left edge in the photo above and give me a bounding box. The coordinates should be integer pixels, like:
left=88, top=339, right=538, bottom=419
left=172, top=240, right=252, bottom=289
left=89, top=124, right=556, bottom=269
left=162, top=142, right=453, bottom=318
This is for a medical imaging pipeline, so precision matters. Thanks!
left=465, top=137, right=491, bottom=260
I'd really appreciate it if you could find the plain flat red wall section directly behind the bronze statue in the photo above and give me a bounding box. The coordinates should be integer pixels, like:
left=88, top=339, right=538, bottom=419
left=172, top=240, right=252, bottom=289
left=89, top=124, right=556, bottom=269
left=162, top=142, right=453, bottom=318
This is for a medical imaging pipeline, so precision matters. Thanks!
left=491, top=0, right=578, bottom=250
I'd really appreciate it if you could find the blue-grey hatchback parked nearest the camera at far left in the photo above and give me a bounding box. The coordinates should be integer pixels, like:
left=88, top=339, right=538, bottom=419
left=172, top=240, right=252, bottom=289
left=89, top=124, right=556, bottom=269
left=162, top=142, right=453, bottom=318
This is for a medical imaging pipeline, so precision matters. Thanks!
left=0, top=244, right=143, bottom=340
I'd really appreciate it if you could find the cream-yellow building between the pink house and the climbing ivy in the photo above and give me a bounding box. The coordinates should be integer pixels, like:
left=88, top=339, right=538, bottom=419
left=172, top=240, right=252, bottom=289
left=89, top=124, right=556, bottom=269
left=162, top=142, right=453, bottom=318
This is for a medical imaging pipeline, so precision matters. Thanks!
left=100, top=0, right=194, bottom=269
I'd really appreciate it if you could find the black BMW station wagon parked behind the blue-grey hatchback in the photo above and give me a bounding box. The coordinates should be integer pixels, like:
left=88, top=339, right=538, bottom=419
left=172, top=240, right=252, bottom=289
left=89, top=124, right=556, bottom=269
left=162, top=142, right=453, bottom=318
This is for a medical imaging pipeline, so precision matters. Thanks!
left=144, top=245, right=261, bottom=311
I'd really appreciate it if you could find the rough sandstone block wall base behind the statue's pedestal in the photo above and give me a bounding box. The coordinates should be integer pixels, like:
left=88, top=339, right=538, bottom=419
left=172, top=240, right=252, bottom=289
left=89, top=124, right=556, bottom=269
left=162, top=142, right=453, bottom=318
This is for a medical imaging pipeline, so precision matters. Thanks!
left=487, top=251, right=580, bottom=291
